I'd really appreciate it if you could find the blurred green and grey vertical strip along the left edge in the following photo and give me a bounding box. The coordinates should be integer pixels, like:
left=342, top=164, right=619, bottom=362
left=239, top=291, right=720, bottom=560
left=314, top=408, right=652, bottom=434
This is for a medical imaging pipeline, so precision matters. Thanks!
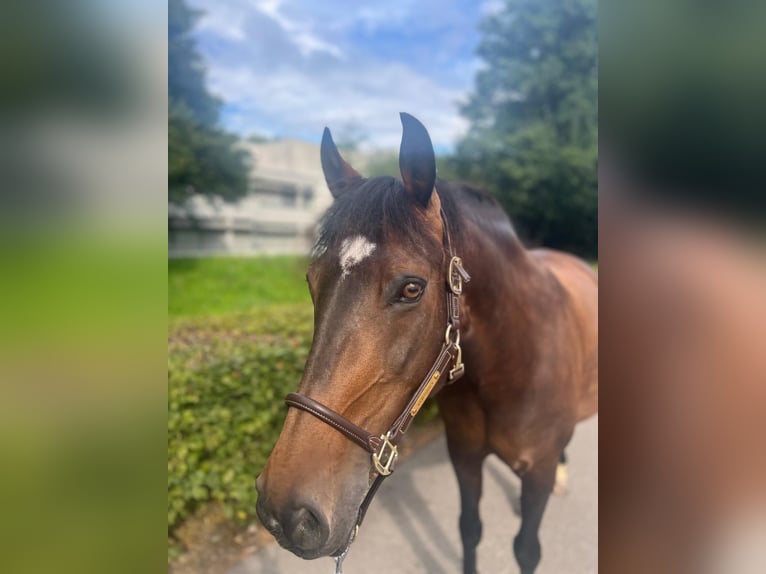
left=0, top=0, right=167, bottom=574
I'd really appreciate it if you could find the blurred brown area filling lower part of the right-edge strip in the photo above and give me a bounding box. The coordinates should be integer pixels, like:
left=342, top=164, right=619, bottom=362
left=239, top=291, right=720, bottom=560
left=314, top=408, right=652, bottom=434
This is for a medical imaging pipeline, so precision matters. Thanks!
left=599, top=174, right=766, bottom=574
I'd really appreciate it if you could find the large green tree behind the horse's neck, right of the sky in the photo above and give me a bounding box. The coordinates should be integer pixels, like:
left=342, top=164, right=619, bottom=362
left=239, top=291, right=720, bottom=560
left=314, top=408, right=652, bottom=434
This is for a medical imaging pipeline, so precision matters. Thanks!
left=454, top=0, right=598, bottom=257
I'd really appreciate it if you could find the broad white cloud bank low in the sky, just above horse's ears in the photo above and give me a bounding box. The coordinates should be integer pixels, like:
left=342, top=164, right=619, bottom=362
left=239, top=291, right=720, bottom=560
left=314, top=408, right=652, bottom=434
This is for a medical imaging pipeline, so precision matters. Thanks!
left=210, top=62, right=467, bottom=148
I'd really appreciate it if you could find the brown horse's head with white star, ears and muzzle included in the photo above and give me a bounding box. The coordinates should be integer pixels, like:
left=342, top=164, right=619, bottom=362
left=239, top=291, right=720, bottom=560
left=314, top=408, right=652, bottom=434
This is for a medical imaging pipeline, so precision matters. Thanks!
left=257, top=114, right=449, bottom=558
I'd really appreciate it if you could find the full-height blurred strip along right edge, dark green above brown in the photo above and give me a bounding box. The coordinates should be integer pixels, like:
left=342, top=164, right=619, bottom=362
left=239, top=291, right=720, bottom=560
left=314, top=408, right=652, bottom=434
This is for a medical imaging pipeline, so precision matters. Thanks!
left=599, top=1, right=766, bottom=574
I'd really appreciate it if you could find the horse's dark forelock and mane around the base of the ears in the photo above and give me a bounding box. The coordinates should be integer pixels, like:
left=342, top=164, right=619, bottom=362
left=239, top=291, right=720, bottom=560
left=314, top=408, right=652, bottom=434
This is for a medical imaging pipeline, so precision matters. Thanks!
left=312, top=176, right=506, bottom=254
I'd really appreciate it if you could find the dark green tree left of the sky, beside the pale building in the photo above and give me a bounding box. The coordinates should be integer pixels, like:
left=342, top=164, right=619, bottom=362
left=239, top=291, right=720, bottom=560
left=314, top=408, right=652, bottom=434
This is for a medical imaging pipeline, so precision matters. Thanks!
left=168, top=0, right=249, bottom=203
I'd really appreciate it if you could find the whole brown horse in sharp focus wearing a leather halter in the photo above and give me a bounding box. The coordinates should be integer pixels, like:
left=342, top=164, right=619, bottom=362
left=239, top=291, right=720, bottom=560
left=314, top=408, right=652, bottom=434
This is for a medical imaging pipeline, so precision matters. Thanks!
left=257, top=114, right=598, bottom=573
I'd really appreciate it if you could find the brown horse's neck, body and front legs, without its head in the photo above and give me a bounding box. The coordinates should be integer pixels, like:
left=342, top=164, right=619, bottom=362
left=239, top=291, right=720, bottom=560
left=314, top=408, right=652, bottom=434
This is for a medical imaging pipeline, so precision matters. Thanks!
left=436, top=185, right=598, bottom=572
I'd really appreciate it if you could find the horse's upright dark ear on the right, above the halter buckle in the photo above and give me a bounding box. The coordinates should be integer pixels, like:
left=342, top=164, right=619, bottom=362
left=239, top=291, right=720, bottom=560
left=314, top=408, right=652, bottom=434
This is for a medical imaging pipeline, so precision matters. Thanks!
left=399, top=112, right=436, bottom=208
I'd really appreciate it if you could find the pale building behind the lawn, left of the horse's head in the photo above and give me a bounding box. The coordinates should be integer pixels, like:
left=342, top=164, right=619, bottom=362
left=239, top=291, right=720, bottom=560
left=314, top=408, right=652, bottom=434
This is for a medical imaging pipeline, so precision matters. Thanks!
left=168, top=141, right=340, bottom=257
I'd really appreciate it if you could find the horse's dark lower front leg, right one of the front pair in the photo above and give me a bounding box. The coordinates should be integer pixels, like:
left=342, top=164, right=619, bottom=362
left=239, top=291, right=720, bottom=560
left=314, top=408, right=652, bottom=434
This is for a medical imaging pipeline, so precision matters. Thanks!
left=513, top=459, right=557, bottom=574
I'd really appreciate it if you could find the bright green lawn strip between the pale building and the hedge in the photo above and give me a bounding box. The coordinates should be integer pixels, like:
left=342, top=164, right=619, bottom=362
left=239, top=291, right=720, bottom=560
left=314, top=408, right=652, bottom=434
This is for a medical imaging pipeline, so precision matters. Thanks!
left=168, top=256, right=311, bottom=320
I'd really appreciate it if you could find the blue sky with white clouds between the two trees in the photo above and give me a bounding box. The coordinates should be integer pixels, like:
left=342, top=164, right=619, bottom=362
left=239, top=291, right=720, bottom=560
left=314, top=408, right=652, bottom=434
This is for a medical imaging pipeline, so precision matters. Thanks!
left=188, top=0, right=504, bottom=151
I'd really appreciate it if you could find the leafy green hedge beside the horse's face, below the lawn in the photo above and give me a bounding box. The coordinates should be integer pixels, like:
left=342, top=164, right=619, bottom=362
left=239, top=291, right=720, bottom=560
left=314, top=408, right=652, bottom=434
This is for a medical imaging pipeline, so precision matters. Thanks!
left=168, top=305, right=312, bottom=533
